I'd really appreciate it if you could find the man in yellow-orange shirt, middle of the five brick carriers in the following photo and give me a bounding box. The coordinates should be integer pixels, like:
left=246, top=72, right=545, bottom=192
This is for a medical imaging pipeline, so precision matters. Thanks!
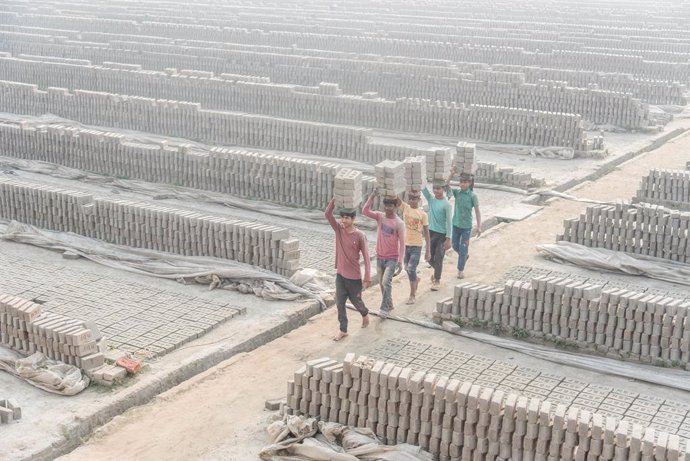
left=398, top=190, right=431, bottom=304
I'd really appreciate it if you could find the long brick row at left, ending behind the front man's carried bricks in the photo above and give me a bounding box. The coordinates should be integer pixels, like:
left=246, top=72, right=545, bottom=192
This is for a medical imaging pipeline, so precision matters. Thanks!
left=0, top=122, right=340, bottom=208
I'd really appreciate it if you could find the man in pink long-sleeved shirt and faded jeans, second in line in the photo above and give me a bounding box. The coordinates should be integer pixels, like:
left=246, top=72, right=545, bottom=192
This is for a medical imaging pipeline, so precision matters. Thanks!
left=362, top=191, right=405, bottom=318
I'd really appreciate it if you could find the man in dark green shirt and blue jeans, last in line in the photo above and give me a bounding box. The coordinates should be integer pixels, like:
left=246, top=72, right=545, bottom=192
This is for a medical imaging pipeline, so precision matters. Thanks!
left=448, top=167, right=482, bottom=279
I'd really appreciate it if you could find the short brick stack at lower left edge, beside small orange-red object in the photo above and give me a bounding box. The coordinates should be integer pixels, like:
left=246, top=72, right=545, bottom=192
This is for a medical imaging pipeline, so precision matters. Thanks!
left=0, top=293, right=105, bottom=370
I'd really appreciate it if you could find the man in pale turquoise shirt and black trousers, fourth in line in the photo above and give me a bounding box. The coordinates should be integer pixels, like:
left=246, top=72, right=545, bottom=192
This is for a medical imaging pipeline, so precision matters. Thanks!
left=422, top=179, right=453, bottom=291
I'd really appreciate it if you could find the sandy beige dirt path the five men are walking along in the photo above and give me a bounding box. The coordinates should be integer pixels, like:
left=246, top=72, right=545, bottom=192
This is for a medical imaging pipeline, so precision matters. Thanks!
left=60, top=134, right=690, bottom=461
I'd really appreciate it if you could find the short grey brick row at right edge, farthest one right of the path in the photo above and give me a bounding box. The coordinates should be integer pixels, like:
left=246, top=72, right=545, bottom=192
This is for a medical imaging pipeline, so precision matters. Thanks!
left=635, top=169, right=690, bottom=211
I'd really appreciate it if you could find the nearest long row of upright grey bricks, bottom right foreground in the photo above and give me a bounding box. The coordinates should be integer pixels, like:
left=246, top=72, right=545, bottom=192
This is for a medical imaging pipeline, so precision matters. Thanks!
left=287, top=353, right=690, bottom=461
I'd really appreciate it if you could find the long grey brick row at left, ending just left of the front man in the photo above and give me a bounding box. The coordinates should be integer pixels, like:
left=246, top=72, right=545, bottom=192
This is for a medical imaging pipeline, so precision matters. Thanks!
left=0, top=178, right=300, bottom=276
